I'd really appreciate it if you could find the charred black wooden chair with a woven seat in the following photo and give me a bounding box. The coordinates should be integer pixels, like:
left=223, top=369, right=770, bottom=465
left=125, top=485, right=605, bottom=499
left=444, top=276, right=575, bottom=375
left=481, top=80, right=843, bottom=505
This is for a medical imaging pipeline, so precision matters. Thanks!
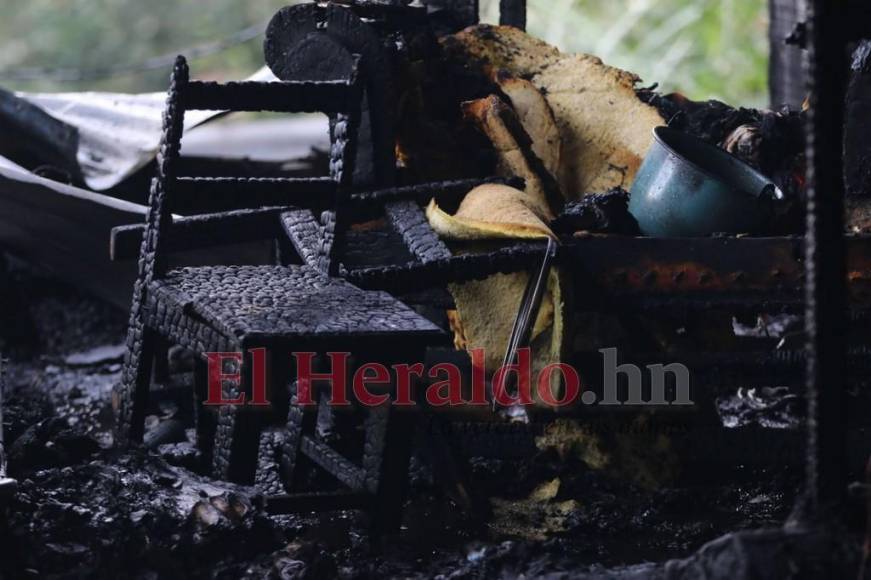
left=115, top=57, right=443, bottom=526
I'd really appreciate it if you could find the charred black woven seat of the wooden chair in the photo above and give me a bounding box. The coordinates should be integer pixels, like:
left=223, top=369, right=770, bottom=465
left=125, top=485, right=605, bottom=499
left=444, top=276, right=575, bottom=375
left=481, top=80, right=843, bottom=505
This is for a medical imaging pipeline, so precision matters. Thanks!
left=148, top=266, right=443, bottom=344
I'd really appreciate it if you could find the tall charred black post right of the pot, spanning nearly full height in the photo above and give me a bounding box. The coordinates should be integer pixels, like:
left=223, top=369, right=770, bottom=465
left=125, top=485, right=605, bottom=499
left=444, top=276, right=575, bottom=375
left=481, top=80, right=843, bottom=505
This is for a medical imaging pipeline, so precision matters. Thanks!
left=805, top=0, right=847, bottom=517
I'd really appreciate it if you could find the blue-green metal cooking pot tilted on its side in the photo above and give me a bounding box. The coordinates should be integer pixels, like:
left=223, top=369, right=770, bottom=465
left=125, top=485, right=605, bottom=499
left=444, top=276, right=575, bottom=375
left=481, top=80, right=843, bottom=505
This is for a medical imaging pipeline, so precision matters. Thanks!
left=629, top=127, right=783, bottom=237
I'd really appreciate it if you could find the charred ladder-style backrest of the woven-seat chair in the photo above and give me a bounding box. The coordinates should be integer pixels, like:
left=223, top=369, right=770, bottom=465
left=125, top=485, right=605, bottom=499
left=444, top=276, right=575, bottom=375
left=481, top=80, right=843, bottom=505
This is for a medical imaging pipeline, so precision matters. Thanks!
left=139, top=56, right=362, bottom=283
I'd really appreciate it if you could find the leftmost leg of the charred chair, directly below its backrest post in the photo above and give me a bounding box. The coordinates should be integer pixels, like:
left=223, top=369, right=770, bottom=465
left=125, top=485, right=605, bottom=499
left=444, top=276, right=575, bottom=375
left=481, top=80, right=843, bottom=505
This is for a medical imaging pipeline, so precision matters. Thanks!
left=112, top=317, right=157, bottom=447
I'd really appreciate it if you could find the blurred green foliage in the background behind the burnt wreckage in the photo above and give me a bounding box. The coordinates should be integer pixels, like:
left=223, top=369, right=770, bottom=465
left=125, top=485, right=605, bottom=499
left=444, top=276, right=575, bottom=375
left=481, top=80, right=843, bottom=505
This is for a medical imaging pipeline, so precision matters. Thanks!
left=0, top=0, right=768, bottom=105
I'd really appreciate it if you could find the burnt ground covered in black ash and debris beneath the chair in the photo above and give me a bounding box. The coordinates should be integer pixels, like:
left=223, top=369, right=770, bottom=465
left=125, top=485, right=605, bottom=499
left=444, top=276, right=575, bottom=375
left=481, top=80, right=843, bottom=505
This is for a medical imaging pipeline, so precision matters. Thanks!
left=0, top=260, right=861, bottom=578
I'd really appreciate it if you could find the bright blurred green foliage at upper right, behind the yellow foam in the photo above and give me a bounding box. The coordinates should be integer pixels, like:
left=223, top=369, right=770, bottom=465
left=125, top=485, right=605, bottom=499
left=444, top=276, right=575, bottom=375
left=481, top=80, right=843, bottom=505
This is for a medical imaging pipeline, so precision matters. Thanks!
left=482, top=0, right=768, bottom=106
